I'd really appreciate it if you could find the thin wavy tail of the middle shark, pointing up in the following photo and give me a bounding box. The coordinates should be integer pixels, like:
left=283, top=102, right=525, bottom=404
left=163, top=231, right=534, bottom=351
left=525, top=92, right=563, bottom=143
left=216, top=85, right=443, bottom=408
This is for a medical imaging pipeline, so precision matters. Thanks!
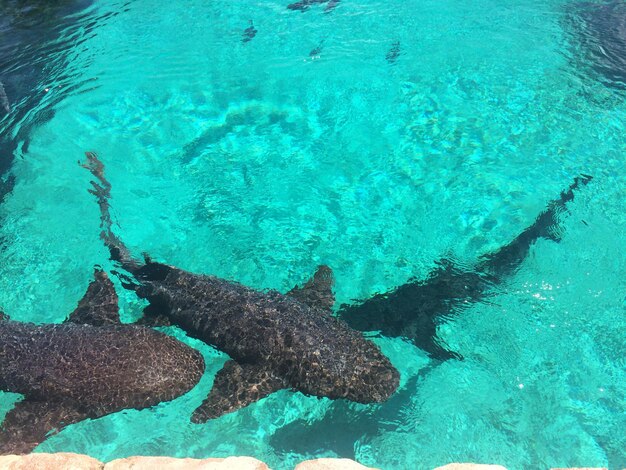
left=78, top=152, right=142, bottom=274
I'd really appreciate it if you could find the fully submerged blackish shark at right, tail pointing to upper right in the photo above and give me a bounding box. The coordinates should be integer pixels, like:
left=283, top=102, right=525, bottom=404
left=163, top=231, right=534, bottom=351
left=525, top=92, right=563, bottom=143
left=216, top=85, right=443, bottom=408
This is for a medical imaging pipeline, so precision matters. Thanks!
left=339, top=175, right=591, bottom=360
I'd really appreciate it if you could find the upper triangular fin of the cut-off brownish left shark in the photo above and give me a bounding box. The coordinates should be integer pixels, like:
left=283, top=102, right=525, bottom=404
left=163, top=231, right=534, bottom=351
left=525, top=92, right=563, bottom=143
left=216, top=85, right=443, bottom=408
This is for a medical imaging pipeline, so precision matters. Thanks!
left=66, top=268, right=120, bottom=326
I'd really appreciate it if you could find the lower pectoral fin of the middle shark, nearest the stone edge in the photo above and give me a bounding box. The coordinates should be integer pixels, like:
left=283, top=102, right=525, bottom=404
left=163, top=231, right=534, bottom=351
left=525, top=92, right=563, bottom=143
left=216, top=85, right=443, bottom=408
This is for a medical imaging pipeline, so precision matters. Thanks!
left=191, top=360, right=286, bottom=423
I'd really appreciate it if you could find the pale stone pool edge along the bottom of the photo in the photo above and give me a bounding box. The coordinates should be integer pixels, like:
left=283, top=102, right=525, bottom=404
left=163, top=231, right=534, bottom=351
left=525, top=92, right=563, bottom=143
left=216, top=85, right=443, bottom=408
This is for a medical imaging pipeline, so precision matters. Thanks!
left=0, top=452, right=606, bottom=470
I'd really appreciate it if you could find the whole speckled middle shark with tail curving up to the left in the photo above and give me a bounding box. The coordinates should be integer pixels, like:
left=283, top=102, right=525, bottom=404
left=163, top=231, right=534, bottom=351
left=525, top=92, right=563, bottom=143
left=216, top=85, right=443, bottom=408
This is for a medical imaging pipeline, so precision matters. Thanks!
left=84, top=153, right=399, bottom=422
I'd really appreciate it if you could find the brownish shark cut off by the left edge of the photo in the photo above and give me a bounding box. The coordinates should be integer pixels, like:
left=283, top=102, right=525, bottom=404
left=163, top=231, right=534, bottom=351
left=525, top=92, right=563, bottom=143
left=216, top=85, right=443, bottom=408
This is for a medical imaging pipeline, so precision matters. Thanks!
left=0, top=271, right=204, bottom=454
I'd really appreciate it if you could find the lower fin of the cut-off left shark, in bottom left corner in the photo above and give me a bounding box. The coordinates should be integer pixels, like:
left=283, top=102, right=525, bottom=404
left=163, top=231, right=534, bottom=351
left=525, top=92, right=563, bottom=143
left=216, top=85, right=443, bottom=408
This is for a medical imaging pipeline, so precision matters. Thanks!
left=0, top=398, right=88, bottom=455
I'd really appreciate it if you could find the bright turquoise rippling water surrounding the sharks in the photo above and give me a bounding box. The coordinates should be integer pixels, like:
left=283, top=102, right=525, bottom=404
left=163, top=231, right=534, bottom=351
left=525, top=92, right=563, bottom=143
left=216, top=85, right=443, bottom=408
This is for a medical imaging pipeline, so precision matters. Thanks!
left=0, top=0, right=626, bottom=469
